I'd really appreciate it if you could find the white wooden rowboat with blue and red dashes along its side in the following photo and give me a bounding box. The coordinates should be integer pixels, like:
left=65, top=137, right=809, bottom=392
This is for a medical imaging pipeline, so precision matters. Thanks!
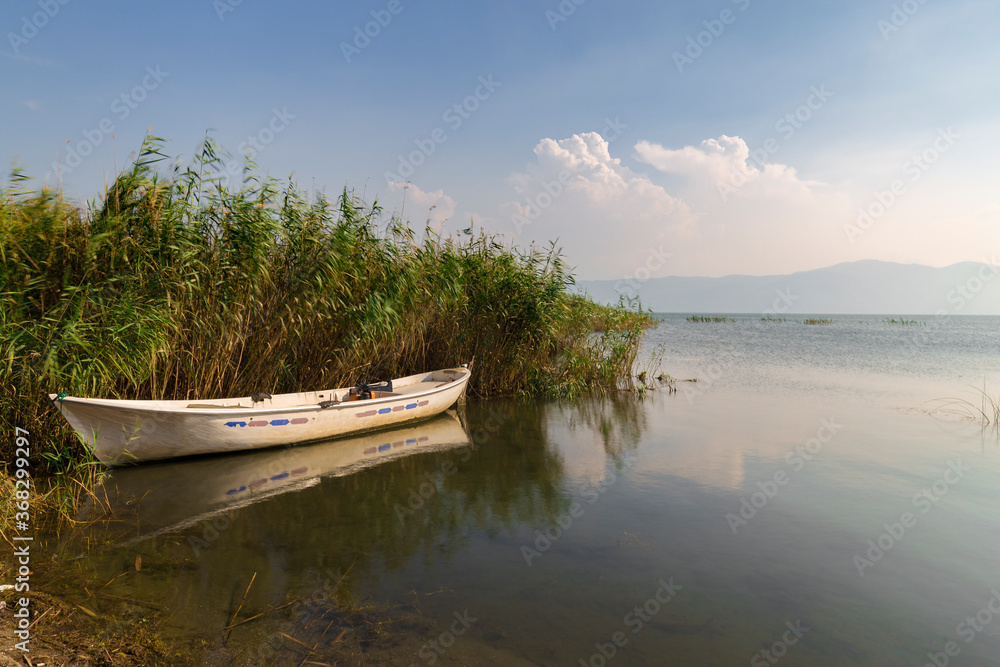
left=49, top=368, right=472, bottom=465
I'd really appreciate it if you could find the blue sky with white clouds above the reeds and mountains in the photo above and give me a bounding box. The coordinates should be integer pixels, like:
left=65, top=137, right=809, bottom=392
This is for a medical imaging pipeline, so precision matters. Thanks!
left=0, top=0, right=1000, bottom=279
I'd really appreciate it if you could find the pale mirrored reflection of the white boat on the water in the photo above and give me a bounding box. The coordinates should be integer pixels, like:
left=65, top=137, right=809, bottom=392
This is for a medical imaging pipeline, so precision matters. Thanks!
left=94, top=411, right=471, bottom=542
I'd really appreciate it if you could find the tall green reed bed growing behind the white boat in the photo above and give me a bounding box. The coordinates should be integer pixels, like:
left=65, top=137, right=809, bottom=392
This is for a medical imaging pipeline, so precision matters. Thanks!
left=0, top=137, right=654, bottom=516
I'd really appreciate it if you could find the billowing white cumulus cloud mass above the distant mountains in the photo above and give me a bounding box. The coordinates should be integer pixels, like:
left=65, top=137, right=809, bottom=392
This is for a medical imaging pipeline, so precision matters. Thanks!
left=504, top=133, right=853, bottom=278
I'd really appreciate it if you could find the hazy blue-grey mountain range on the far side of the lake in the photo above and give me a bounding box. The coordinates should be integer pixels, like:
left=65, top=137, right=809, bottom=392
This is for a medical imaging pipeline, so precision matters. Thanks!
left=577, top=260, right=1000, bottom=315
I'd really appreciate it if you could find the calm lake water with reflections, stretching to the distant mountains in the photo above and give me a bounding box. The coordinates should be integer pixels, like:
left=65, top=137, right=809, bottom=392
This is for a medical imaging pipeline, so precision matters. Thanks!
left=49, top=315, right=1000, bottom=667
